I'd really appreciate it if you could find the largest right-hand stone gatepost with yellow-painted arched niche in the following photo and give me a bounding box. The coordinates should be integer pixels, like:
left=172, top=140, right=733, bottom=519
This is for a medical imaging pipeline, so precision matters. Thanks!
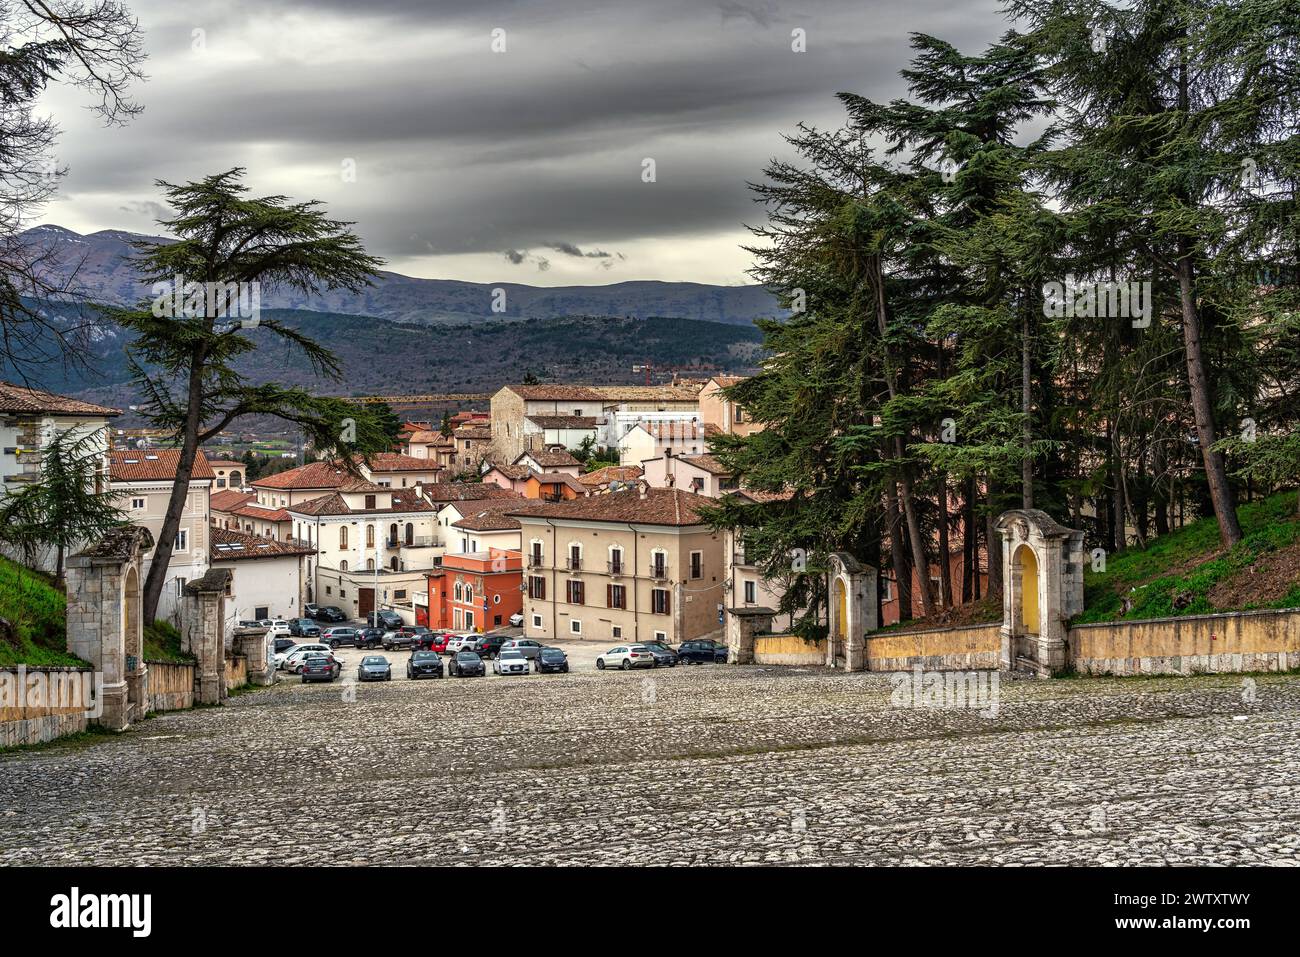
left=997, top=508, right=1083, bottom=677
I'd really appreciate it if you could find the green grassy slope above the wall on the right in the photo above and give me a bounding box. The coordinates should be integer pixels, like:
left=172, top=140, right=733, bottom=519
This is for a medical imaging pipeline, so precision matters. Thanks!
left=1074, top=492, right=1300, bottom=623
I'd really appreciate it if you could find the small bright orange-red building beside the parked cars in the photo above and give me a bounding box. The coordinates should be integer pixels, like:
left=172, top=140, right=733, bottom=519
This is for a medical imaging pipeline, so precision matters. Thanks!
left=416, top=549, right=524, bottom=632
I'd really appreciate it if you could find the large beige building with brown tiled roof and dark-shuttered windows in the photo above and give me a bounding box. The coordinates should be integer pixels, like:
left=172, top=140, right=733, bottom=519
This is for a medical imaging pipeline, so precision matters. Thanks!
left=508, top=485, right=727, bottom=644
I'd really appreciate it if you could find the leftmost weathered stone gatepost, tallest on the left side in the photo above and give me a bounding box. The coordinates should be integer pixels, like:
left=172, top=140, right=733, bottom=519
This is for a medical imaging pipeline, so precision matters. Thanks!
left=66, top=525, right=153, bottom=731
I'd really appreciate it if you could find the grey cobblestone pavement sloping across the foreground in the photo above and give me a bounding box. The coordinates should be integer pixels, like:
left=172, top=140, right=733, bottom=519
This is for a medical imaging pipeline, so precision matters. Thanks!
left=0, top=666, right=1300, bottom=865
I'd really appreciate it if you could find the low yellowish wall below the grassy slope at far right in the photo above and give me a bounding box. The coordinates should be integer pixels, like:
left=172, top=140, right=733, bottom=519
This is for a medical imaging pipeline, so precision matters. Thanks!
left=1066, top=610, right=1300, bottom=675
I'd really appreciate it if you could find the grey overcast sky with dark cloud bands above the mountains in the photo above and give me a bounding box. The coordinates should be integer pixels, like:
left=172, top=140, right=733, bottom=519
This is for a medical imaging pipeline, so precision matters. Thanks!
left=32, top=0, right=1006, bottom=285
